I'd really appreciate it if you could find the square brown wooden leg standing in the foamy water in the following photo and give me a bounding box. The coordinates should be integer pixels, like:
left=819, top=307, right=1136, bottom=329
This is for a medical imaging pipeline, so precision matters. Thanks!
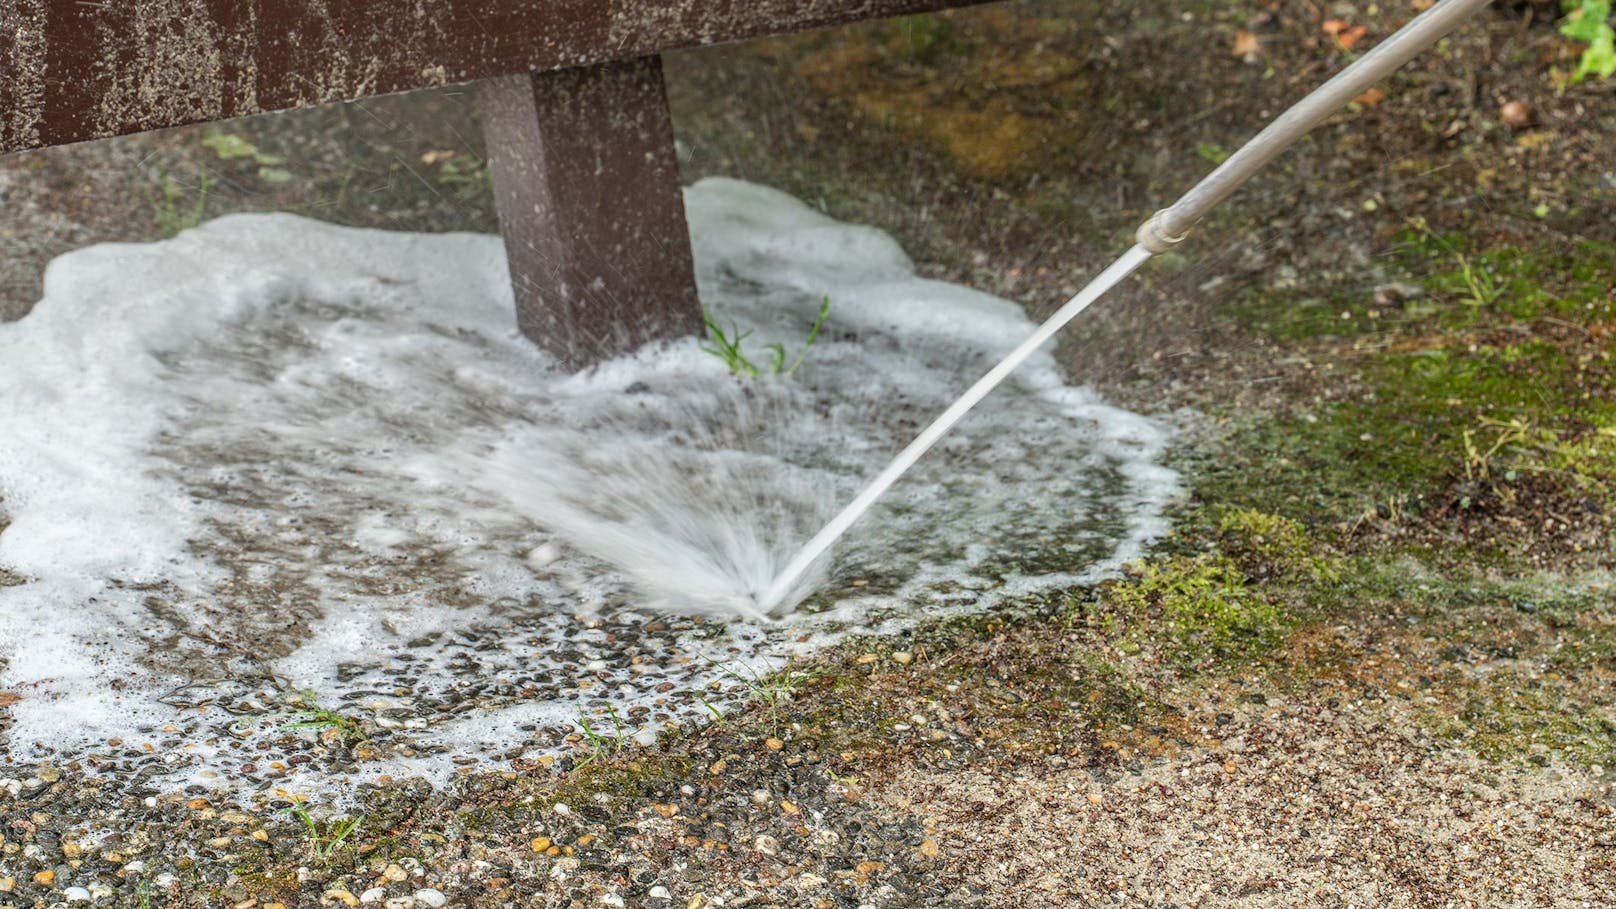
left=477, top=57, right=701, bottom=370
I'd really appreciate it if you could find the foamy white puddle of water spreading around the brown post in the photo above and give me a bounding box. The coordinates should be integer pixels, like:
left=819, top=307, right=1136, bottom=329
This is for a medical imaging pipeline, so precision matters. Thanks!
left=0, top=180, right=1175, bottom=793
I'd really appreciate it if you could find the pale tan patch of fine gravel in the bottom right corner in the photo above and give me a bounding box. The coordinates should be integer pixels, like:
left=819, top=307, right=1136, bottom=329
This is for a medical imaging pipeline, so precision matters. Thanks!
left=869, top=700, right=1616, bottom=907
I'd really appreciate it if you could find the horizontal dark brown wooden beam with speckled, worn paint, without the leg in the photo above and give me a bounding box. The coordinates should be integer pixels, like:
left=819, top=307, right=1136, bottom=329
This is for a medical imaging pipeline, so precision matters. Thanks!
left=0, top=0, right=979, bottom=152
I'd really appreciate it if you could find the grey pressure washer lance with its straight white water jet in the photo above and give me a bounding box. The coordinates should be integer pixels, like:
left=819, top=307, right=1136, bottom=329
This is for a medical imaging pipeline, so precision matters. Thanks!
left=758, top=0, right=1490, bottom=613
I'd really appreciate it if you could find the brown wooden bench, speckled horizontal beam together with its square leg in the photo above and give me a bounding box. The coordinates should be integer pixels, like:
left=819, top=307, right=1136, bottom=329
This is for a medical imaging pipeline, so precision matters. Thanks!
left=0, top=0, right=979, bottom=369
